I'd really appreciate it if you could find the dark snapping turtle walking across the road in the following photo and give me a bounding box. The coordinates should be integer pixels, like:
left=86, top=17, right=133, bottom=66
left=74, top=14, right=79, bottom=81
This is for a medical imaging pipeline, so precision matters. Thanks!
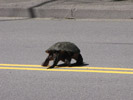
left=42, top=42, right=83, bottom=69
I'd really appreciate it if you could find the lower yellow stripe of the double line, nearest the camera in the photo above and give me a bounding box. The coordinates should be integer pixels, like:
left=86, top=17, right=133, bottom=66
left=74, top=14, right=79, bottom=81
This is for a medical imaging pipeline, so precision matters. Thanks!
left=0, top=67, right=133, bottom=74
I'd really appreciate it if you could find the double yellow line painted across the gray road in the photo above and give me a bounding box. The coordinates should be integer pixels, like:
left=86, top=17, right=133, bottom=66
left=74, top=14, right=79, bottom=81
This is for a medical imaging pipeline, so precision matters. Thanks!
left=0, top=64, right=133, bottom=74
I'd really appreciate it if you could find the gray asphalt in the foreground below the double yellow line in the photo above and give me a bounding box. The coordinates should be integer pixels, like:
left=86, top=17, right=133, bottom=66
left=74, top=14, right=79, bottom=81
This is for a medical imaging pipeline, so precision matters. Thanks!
left=0, top=70, right=133, bottom=100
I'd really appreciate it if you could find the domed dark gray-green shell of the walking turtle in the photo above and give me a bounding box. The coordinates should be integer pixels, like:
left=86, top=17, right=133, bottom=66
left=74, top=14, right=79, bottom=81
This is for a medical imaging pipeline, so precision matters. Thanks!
left=46, top=42, right=80, bottom=53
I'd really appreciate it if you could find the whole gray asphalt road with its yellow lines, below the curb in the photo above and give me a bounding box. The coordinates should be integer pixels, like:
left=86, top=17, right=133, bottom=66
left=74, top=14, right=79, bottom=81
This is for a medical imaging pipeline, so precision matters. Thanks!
left=0, top=19, right=133, bottom=100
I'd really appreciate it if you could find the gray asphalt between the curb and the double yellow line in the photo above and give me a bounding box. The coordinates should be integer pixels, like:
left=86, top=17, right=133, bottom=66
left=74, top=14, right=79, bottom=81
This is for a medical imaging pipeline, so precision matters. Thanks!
left=0, top=19, right=133, bottom=68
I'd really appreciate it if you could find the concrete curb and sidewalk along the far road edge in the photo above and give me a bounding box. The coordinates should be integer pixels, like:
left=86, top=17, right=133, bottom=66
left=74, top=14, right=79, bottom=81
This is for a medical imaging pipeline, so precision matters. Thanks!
left=0, top=0, right=133, bottom=19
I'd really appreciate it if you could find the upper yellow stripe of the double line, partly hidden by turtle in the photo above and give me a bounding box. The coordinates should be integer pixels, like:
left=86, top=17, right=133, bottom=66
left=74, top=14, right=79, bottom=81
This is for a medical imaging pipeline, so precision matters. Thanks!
left=0, top=64, right=133, bottom=71
